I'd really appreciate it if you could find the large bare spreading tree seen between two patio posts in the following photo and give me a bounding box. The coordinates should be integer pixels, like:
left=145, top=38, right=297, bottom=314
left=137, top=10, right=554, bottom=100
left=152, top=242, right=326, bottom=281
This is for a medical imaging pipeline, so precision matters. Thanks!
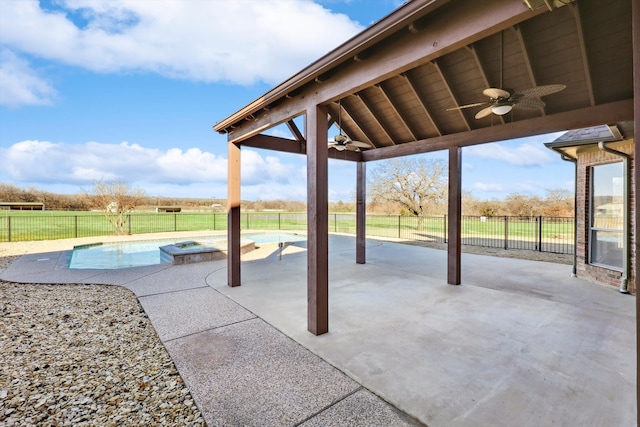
left=367, top=158, right=447, bottom=220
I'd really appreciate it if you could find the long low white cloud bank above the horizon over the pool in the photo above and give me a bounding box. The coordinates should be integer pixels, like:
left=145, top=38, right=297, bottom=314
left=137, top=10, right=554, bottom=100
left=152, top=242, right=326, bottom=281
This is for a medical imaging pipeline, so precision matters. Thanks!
left=0, top=141, right=304, bottom=190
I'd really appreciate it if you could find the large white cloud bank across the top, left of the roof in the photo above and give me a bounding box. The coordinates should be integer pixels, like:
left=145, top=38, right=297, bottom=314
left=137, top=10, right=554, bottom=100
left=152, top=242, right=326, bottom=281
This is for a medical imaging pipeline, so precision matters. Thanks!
left=0, top=0, right=362, bottom=84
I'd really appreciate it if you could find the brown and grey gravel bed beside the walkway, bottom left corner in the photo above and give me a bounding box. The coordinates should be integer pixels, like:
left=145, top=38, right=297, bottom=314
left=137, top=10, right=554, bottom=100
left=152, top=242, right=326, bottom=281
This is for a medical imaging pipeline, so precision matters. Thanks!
left=0, top=257, right=205, bottom=426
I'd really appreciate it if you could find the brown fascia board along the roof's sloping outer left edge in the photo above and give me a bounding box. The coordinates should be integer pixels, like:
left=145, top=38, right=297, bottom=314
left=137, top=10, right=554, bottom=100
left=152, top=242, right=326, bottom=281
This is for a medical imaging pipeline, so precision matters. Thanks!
left=214, top=0, right=450, bottom=132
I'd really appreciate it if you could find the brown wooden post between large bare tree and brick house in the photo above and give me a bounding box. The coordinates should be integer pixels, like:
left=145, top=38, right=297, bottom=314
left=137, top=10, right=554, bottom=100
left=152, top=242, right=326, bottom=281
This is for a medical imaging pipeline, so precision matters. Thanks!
left=447, top=147, right=462, bottom=285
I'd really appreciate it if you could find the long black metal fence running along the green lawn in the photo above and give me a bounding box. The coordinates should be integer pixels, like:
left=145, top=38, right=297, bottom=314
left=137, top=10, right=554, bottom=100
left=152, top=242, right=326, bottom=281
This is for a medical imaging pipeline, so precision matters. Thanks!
left=0, top=212, right=574, bottom=254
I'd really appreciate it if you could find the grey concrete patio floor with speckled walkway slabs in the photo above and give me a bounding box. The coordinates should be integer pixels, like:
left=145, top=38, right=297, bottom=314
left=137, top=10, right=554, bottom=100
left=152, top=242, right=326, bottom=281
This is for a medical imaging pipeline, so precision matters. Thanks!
left=0, top=236, right=637, bottom=427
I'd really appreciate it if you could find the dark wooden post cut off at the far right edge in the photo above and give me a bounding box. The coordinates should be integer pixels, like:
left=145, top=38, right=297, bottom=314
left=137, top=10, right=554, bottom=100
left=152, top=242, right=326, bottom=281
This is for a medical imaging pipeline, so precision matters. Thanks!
left=631, top=1, right=640, bottom=419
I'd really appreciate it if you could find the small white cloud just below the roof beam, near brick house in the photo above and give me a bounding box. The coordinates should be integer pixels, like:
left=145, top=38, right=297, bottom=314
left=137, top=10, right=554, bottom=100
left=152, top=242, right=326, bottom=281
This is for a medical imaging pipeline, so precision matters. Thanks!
left=464, top=142, right=555, bottom=166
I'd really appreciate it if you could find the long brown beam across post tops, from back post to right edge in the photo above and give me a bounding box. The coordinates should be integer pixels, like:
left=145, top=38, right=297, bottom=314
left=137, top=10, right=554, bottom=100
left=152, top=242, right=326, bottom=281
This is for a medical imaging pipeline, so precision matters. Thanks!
left=362, top=99, right=633, bottom=162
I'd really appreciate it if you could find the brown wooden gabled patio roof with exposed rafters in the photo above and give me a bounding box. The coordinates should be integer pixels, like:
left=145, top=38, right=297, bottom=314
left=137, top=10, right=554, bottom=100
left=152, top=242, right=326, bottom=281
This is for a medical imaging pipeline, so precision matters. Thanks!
left=214, top=0, right=633, bottom=161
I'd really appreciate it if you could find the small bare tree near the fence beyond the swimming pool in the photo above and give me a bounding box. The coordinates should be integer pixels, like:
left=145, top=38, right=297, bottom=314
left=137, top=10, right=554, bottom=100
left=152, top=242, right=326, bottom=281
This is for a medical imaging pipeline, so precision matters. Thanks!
left=82, top=181, right=146, bottom=234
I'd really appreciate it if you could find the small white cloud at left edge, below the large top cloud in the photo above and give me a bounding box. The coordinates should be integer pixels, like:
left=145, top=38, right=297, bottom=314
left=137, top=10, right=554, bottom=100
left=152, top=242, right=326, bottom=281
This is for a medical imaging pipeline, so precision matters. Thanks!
left=0, top=48, right=56, bottom=108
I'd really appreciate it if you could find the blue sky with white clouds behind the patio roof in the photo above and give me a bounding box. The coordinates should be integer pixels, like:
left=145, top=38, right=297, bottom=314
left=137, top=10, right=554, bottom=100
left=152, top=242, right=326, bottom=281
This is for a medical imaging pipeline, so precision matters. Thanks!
left=0, top=0, right=573, bottom=202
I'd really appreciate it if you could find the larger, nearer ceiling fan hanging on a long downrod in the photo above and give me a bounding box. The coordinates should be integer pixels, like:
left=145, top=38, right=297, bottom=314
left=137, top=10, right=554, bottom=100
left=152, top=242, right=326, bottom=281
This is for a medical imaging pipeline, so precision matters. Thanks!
left=447, top=32, right=567, bottom=119
